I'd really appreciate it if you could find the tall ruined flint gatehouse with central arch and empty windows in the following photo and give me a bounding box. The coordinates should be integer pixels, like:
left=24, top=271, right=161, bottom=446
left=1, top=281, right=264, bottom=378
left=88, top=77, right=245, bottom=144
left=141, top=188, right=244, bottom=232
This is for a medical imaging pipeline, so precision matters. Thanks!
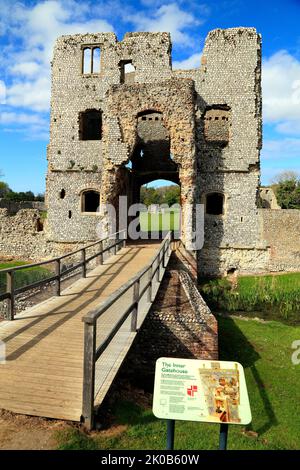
left=46, top=28, right=269, bottom=274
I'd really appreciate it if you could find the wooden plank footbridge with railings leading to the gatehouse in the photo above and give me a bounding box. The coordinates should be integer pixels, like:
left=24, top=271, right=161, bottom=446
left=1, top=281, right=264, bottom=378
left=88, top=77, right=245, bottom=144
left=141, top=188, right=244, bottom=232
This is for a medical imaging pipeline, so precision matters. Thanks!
left=0, top=233, right=171, bottom=428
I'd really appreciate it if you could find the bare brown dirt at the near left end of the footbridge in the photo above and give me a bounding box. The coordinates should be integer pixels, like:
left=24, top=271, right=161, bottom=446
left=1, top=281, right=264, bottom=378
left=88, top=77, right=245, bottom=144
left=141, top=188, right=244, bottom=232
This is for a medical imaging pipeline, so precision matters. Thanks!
left=0, top=410, right=70, bottom=450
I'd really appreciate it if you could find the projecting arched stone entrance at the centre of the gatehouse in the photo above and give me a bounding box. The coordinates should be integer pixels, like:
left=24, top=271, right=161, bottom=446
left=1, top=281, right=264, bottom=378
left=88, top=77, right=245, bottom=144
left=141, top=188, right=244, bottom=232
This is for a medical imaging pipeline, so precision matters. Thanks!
left=101, top=80, right=196, bottom=243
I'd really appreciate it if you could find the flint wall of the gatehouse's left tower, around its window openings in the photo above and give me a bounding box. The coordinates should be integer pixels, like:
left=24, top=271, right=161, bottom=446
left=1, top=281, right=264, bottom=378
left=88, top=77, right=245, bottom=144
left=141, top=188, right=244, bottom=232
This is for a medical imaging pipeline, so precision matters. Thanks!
left=47, top=33, right=171, bottom=242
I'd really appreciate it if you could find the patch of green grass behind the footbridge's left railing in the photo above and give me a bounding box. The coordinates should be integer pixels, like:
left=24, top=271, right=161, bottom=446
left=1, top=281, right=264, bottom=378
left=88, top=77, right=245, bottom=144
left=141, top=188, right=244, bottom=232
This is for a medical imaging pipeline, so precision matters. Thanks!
left=0, top=261, right=53, bottom=294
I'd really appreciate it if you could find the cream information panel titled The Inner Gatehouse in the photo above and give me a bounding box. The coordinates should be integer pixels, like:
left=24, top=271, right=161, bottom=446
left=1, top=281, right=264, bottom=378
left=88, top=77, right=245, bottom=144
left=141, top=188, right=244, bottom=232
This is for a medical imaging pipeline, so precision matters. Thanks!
left=153, top=358, right=251, bottom=424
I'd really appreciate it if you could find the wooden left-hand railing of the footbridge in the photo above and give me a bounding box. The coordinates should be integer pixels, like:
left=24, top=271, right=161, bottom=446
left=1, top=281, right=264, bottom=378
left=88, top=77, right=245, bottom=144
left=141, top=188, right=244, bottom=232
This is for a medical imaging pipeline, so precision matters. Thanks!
left=0, top=230, right=126, bottom=320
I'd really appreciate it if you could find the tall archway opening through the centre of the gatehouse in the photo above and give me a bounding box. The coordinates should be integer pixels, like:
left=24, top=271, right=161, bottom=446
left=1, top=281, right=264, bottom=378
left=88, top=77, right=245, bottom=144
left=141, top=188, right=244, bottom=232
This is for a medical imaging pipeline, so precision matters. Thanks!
left=120, top=109, right=180, bottom=238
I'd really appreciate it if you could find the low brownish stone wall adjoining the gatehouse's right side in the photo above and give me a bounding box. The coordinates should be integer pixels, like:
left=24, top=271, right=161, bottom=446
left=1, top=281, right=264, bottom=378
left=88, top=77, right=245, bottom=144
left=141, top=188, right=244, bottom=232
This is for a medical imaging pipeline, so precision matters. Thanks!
left=259, top=209, right=300, bottom=271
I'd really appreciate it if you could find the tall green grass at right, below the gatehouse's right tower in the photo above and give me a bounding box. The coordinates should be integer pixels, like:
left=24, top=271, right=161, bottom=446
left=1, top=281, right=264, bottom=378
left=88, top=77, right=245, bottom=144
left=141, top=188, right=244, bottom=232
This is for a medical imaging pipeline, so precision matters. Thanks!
left=200, top=273, right=300, bottom=324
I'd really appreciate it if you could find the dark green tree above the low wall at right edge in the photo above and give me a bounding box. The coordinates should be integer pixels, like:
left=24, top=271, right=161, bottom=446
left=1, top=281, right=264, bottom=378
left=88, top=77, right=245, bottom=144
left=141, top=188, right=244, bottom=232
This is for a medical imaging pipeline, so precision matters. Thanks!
left=272, top=171, right=300, bottom=209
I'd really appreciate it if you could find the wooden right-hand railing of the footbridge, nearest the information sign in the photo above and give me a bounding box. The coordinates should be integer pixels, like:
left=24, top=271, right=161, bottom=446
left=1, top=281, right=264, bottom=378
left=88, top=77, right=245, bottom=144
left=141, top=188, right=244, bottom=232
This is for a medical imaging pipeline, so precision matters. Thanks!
left=82, top=232, right=172, bottom=429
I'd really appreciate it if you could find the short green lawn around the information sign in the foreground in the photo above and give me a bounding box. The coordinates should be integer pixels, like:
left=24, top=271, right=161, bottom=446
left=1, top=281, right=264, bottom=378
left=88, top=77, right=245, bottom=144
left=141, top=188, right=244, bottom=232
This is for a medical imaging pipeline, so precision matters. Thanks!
left=56, top=317, right=300, bottom=450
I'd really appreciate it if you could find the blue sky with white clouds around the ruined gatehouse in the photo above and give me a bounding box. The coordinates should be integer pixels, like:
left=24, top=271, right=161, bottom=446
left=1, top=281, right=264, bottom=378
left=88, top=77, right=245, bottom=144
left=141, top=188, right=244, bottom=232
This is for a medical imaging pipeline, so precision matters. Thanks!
left=0, top=0, right=300, bottom=193
